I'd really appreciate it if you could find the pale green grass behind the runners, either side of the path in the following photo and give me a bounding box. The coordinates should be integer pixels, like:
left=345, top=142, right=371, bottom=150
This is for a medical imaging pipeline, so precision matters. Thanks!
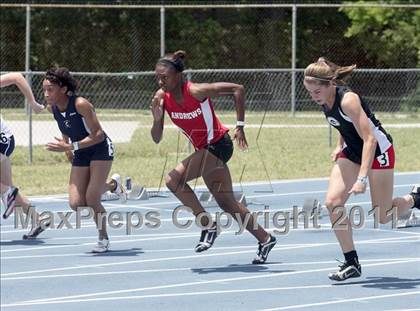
left=2, top=109, right=420, bottom=195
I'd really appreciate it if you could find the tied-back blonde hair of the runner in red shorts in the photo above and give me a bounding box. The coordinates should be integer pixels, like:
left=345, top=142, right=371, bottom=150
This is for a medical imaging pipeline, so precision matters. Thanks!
left=304, top=57, right=356, bottom=85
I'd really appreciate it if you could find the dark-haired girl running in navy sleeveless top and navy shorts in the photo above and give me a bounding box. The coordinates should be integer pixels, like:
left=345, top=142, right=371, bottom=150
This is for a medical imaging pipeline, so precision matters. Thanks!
left=42, top=68, right=122, bottom=253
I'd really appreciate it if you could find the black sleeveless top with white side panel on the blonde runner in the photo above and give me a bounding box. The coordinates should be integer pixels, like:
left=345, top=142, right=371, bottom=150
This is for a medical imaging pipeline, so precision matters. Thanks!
left=322, top=86, right=392, bottom=158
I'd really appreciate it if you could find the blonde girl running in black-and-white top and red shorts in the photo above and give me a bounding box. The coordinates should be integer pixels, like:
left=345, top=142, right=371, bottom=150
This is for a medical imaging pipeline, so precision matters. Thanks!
left=304, top=58, right=420, bottom=281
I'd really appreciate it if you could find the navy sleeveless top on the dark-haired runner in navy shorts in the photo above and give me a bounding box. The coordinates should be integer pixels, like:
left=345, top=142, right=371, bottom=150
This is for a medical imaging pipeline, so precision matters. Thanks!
left=52, top=96, right=106, bottom=142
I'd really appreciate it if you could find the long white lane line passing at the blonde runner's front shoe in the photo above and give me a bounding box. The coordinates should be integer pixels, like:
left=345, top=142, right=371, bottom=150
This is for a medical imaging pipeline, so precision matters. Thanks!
left=1, top=259, right=420, bottom=307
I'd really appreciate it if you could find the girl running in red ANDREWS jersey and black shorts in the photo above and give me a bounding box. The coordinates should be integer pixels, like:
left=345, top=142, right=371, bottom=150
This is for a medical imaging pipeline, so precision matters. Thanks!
left=151, top=51, right=276, bottom=264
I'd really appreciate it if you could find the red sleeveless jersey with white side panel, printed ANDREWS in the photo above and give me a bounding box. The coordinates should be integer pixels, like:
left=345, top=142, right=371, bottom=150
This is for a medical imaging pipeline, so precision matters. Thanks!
left=163, top=81, right=229, bottom=150
